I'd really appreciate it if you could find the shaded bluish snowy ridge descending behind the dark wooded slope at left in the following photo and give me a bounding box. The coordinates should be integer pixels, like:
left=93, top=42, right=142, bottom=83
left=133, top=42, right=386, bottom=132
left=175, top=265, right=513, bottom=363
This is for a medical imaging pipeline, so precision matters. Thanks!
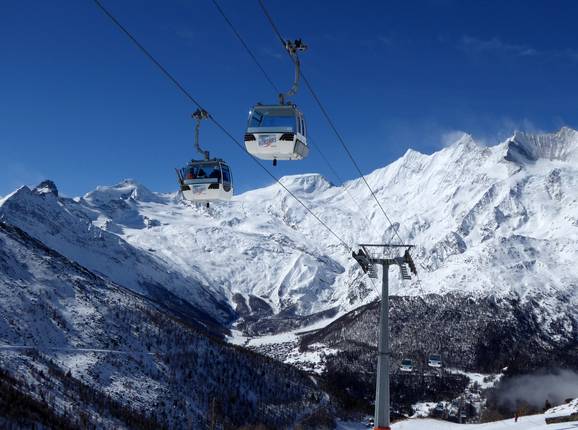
left=0, top=181, right=232, bottom=330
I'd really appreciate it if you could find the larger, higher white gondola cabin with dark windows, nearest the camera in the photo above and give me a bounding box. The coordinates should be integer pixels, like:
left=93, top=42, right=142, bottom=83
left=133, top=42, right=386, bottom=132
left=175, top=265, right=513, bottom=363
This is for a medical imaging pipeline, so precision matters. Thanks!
left=245, top=104, right=309, bottom=164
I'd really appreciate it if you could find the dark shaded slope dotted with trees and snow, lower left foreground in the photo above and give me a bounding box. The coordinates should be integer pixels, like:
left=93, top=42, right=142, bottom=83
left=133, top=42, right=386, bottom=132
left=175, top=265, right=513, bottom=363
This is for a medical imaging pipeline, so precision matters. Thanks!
left=0, top=222, right=321, bottom=429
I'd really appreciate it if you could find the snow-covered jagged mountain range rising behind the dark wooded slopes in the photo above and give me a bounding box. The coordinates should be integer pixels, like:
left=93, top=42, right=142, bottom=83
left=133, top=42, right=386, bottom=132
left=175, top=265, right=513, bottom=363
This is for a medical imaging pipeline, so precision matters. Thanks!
left=0, top=128, right=578, bottom=335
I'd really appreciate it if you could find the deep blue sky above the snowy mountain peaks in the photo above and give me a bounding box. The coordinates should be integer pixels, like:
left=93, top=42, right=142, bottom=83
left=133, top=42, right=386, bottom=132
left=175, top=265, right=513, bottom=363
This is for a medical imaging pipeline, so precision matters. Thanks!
left=0, top=0, right=578, bottom=196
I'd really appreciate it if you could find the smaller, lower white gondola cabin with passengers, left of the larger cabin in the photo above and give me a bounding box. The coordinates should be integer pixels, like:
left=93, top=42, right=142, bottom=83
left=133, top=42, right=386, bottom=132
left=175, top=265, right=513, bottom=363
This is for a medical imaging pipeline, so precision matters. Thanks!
left=177, top=159, right=233, bottom=203
